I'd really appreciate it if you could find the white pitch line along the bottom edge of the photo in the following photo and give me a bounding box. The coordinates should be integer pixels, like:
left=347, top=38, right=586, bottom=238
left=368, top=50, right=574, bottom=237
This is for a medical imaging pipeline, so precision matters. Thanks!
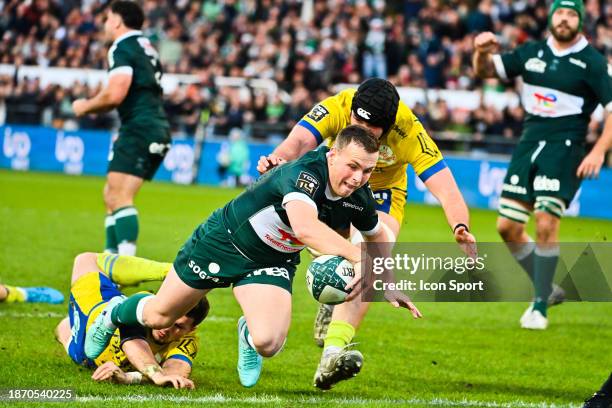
left=77, top=394, right=579, bottom=408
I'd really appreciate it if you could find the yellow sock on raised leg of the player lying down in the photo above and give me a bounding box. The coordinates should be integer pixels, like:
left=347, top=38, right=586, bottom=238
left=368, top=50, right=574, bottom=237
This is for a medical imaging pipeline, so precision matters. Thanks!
left=97, top=254, right=172, bottom=286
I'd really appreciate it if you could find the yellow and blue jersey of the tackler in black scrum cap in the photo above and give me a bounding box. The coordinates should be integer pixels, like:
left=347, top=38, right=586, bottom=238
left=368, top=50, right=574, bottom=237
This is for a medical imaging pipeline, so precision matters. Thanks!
left=298, top=89, right=446, bottom=224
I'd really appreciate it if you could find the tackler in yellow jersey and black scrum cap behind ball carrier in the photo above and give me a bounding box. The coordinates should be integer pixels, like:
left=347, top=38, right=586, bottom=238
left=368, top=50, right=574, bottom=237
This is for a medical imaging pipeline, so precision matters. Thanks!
left=257, top=78, right=476, bottom=389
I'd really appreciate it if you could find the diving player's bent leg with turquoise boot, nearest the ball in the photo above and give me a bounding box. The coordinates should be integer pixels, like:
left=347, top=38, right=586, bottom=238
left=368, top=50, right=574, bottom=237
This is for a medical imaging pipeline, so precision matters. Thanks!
left=234, top=283, right=291, bottom=387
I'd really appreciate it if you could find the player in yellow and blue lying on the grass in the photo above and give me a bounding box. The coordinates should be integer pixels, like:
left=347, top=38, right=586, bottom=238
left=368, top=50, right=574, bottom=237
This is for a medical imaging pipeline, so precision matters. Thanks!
left=55, top=253, right=209, bottom=388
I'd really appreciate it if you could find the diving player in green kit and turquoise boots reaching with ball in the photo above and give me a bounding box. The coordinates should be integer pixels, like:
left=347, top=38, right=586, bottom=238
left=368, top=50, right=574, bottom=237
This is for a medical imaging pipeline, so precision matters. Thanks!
left=85, top=126, right=420, bottom=387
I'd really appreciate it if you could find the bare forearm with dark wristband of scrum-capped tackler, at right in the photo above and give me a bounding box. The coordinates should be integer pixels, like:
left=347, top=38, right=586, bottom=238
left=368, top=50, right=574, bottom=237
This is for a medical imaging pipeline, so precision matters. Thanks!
left=425, top=168, right=477, bottom=257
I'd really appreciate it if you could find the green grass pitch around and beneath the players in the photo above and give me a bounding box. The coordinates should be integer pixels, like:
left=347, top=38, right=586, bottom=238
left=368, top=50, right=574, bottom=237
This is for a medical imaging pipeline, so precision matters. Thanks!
left=0, top=167, right=612, bottom=407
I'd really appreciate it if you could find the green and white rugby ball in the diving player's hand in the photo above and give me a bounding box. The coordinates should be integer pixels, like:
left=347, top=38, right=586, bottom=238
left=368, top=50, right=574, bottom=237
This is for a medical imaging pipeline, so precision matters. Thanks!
left=306, top=255, right=355, bottom=305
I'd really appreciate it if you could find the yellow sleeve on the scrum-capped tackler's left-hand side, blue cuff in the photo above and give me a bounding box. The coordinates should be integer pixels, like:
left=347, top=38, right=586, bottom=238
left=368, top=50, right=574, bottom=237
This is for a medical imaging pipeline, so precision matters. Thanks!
left=297, top=89, right=356, bottom=145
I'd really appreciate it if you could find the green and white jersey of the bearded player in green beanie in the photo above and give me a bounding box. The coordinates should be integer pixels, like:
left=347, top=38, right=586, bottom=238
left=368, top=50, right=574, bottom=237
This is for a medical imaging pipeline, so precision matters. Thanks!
left=493, top=37, right=612, bottom=141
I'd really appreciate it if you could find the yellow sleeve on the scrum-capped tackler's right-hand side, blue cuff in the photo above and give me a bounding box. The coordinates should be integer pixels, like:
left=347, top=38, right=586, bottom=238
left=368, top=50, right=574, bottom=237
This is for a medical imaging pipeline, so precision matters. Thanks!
left=392, top=102, right=446, bottom=181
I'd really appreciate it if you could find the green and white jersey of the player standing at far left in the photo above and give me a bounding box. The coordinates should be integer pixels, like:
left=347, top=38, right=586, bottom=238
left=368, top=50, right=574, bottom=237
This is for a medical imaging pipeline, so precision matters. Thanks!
left=108, top=30, right=169, bottom=127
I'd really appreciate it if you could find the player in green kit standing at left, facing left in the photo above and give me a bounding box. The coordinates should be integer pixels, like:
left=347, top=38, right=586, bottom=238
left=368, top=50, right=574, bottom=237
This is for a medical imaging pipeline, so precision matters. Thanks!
left=72, top=1, right=170, bottom=255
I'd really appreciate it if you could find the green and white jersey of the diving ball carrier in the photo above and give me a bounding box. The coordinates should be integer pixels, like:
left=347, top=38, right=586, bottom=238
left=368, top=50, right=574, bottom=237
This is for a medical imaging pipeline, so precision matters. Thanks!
left=222, top=147, right=380, bottom=264
